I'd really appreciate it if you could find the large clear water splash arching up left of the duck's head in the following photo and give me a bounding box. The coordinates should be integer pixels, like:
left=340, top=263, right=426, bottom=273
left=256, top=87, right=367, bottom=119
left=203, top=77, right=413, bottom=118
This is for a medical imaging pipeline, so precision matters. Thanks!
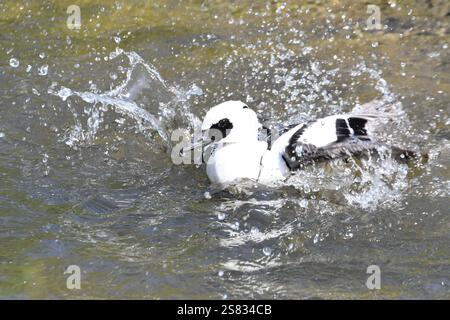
left=48, top=48, right=203, bottom=146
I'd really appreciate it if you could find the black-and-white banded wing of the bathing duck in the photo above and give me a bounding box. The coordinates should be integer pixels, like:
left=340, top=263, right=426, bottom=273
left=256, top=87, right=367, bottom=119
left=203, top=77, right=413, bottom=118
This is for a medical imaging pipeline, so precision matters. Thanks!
left=274, top=114, right=377, bottom=170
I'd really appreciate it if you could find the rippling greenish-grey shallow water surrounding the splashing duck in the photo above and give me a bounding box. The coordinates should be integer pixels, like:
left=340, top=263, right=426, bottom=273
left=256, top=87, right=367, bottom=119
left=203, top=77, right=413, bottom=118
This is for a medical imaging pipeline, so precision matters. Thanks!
left=0, top=0, right=450, bottom=299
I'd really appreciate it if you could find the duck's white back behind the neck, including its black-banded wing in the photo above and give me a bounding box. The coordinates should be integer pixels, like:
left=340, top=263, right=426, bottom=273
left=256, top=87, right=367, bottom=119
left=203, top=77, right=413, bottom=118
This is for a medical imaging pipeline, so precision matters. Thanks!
left=259, top=114, right=373, bottom=182
